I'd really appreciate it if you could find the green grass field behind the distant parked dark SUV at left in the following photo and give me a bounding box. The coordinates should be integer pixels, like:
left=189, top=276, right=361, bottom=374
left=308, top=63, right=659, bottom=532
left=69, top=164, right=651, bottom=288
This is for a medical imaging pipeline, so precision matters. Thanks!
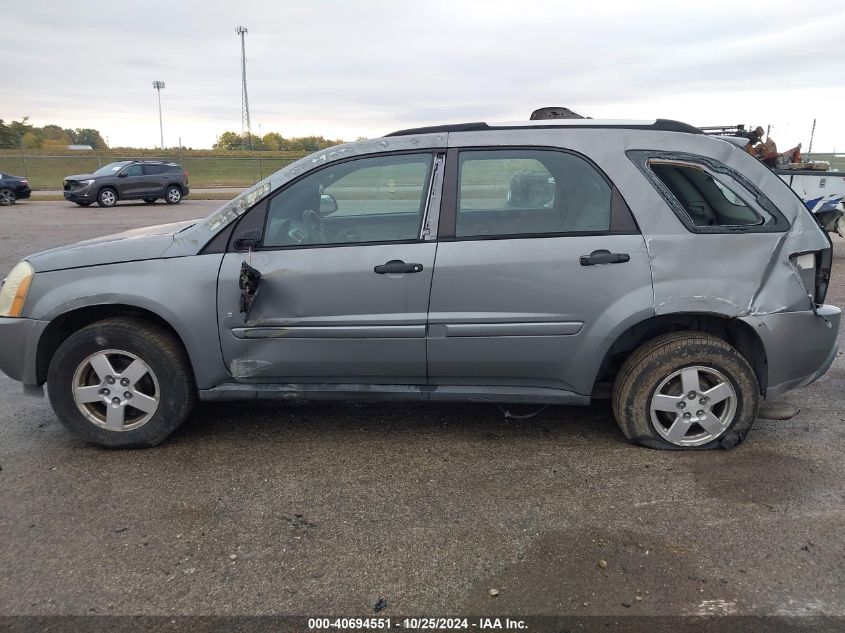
left=0, top=150, right=305, bottom=190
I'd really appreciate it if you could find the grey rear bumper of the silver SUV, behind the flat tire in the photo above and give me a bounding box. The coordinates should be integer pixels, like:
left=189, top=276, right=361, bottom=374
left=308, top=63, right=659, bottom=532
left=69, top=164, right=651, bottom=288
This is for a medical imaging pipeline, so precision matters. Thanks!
left=742, top=305, right=842, bottom=399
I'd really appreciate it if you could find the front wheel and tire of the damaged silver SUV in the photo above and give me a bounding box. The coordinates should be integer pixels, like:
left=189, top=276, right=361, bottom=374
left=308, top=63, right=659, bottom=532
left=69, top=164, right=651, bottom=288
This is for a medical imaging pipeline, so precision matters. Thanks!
left=47, top=318, right=196, bottom=448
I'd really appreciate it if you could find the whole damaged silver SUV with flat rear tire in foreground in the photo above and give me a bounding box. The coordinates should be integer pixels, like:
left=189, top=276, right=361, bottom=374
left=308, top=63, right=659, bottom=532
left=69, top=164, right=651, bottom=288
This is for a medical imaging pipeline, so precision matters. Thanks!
left=0, top=119, right=840, bottom=449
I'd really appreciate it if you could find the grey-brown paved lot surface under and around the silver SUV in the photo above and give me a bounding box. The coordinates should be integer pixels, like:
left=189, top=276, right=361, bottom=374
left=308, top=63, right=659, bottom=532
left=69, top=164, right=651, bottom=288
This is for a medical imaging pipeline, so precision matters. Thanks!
left=0, top=199, right=845, bottom=616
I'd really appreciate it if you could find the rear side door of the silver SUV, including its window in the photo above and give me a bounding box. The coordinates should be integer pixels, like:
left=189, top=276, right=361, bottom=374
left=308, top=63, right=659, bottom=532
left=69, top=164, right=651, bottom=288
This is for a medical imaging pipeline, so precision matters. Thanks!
left=428, top=147, right=653, bottom=394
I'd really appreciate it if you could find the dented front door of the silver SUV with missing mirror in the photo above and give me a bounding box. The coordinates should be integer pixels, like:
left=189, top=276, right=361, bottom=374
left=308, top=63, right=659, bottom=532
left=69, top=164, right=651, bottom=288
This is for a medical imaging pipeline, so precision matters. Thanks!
left=217, top=152, right=436, bottom=384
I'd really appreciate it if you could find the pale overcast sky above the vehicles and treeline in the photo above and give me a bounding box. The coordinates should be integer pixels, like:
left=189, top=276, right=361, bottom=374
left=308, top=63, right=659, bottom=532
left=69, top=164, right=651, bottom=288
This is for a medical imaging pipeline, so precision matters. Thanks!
left=0, top=0, right=845, bottom=152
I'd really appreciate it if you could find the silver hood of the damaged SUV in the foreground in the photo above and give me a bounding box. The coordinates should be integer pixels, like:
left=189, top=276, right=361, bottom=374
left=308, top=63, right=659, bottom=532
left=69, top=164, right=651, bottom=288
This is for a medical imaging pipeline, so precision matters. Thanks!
left=26, top=220, right=198, bottom=272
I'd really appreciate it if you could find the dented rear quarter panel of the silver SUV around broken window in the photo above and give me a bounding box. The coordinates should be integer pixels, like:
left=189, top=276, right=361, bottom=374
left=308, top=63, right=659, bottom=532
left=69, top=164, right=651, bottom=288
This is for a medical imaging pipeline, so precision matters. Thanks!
left=449, top=128, right=829, bottom=317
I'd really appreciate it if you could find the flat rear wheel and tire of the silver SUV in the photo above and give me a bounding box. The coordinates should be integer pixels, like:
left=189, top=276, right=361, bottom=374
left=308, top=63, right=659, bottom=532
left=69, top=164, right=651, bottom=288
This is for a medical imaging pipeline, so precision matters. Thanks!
left=613, top=332, right=760, bottom=450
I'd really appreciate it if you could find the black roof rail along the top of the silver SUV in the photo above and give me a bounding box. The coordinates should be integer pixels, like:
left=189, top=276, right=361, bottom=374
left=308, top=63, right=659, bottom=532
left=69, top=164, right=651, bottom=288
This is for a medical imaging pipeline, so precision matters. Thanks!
left=385, top=119, right=704, bottom=137
